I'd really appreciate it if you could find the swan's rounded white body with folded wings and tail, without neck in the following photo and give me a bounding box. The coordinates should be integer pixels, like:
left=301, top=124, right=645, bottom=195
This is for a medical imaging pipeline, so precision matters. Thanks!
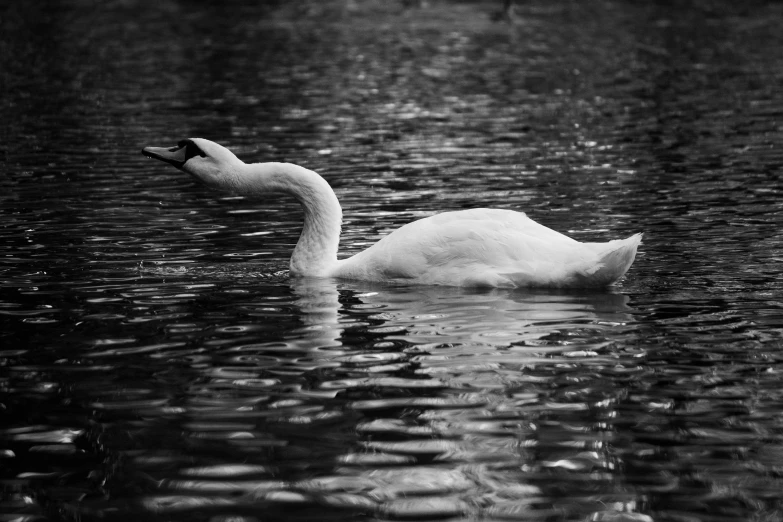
left=334, top=209, right=641, bottom=287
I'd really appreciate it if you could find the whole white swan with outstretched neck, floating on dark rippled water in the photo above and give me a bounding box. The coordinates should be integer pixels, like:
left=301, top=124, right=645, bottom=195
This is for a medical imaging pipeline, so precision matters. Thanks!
left=142, top=138, right=642, bottom=288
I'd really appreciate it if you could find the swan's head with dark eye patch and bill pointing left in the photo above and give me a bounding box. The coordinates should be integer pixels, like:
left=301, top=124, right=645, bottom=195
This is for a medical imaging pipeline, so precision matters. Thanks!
left=141, top=138, right=244, bottom=190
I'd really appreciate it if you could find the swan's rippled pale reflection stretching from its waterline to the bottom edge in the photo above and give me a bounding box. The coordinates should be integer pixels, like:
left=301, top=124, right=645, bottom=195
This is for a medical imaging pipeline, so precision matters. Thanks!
left=276, top=279, right=636, bottom=518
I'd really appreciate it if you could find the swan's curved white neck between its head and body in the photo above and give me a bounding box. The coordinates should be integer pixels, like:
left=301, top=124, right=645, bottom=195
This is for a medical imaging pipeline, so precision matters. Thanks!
left=240, top=163, right=343, bottom=277
